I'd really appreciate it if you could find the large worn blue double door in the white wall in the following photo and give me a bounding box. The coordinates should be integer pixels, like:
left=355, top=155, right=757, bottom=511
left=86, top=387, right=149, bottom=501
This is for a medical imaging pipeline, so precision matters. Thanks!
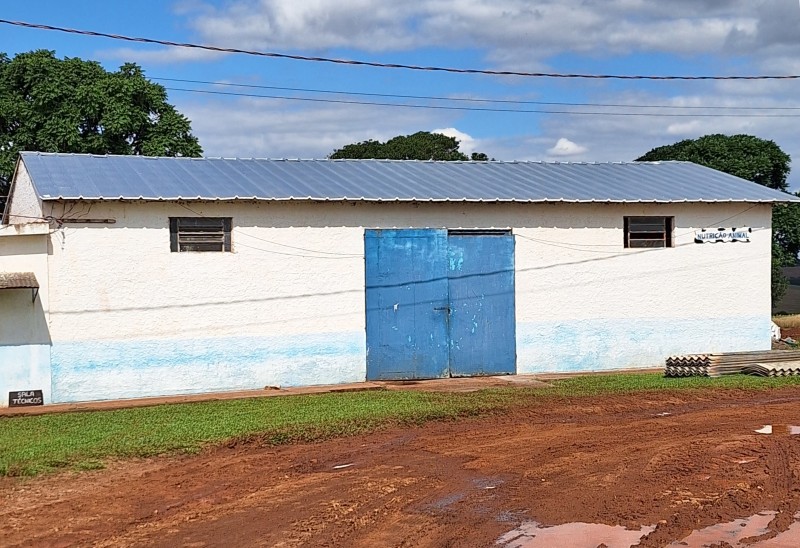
left=364, top=229, right=516, bottom=380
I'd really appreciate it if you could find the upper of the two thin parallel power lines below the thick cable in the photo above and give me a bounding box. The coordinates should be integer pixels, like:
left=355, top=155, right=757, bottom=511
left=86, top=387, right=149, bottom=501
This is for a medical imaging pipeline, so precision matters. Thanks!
left=149, top=76, right=800, bottom=110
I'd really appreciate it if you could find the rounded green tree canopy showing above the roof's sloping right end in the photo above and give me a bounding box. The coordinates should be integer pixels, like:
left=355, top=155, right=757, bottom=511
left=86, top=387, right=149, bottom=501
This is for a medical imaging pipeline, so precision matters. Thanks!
left=636, top=134, right=791, bottom=190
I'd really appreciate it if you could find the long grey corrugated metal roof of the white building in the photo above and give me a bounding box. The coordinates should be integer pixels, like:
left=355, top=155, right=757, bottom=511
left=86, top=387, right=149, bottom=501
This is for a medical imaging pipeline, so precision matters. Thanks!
left=22, top=152, right=798, bottom=202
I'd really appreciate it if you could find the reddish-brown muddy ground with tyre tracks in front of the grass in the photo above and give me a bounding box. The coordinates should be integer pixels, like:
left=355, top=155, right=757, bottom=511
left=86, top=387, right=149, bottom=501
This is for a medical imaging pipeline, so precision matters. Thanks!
left=0, top=389, right=800, bottom=547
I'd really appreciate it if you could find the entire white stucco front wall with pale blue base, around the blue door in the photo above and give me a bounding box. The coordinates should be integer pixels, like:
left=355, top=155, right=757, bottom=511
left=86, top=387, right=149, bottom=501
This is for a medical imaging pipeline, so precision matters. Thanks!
left=12, top=202, right=771, bottom=401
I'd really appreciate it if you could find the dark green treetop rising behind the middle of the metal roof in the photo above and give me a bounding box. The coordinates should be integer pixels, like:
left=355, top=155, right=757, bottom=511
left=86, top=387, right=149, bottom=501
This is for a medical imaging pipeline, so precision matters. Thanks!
left=328, top=131, right=489, bottom=161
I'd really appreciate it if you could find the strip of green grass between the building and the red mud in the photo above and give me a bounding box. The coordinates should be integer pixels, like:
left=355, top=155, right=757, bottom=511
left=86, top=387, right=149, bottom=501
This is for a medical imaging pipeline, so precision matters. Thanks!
left=0, top=373, right=800, bottom=476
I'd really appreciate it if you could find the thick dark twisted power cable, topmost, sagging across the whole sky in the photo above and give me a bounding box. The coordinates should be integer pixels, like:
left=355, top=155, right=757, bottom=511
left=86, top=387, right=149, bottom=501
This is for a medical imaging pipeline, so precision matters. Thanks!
left=0, top=19, right=800, bottom=80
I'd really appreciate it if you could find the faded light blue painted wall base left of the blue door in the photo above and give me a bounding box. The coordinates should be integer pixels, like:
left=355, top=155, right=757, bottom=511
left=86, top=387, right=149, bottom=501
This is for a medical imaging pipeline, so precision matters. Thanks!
left=52, top=332, right=366, bottom=403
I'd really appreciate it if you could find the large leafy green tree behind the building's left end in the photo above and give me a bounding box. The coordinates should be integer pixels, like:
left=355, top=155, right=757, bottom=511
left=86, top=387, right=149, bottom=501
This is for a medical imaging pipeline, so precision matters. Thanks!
left=0, top=50, right=203, bottom=199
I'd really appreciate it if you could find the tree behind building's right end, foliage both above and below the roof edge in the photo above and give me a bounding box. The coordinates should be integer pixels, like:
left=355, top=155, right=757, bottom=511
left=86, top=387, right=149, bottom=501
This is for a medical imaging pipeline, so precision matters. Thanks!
left=636, top=134, right=800, bottom=305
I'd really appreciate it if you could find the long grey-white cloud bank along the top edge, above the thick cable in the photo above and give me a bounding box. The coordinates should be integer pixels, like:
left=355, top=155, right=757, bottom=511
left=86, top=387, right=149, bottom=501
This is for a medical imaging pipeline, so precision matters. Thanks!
left=173, top=0, right=788, bottom=59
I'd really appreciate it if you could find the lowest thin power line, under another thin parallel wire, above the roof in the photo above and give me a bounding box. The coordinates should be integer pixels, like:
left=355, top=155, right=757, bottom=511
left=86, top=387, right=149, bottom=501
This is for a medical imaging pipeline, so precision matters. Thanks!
left=165, top=87, right=800, bottom=118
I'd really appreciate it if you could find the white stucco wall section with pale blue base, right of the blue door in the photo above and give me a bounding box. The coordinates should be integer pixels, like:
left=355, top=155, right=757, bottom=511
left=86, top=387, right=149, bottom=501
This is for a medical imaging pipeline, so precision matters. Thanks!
left=516, top=204, right=771, bottom=373
